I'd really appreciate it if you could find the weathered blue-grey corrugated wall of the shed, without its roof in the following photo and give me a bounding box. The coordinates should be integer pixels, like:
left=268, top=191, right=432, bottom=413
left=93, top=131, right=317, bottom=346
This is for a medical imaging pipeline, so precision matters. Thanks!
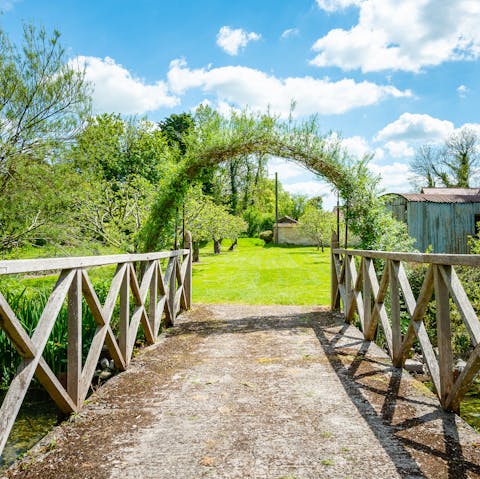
left=407, top=201, right=480, bottom=253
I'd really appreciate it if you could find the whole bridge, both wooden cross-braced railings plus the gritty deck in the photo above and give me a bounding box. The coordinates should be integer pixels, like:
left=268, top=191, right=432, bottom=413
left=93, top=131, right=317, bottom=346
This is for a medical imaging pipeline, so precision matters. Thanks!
left=0, top=238, right=480, bottom=479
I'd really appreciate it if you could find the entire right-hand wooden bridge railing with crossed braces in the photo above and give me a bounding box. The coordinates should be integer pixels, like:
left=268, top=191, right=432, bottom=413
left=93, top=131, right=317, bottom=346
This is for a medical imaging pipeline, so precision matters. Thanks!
left=331, top=232, right=480, bottom=411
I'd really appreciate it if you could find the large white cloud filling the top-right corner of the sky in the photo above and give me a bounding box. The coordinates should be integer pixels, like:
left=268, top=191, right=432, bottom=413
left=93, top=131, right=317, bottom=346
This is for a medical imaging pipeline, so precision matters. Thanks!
left=311, top=0, right=480, bottom=72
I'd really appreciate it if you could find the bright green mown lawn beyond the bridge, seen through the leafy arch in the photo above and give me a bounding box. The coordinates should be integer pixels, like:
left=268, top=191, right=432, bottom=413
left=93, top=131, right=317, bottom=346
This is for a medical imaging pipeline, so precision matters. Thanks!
left=193, top=238, right=330, bottom=305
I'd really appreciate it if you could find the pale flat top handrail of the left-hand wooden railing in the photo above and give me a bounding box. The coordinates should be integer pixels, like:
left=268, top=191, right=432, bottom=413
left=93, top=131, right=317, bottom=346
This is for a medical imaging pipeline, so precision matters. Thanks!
left=0, top=249, right=189, bottom=276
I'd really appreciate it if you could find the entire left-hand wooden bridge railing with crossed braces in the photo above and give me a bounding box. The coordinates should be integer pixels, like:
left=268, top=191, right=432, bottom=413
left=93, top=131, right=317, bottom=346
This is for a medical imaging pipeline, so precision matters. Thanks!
left=0, top=233, right=192, bottom=454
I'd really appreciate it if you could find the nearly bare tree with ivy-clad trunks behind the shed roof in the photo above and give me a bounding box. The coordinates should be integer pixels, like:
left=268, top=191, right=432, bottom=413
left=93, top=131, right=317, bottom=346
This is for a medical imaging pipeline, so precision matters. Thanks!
left=410, top=127, right=480, bottom=188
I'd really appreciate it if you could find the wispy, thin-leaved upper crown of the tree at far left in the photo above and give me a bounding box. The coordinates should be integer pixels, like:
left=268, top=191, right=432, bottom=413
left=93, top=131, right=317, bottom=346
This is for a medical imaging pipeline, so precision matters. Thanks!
left=0, top=25, right=90, bottom=193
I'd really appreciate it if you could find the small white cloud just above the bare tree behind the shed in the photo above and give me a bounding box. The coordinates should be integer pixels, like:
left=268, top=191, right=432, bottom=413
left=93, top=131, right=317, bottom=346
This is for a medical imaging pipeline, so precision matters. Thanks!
left=375, top=113, right=454, bottom=143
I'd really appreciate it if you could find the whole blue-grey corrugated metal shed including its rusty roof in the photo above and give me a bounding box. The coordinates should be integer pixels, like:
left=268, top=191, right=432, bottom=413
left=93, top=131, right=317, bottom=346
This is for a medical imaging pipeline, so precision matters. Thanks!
left=387, top=188, right=480, bottom=253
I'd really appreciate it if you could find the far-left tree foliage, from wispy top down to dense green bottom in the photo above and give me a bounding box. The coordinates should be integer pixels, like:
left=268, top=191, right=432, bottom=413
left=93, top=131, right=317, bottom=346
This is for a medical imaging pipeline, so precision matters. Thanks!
left=0, top=25, right=90, bottom=251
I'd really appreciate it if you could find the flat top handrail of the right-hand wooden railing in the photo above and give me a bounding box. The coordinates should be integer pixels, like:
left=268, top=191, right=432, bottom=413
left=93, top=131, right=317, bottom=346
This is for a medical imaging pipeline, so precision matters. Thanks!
left=332, top=248, right=480, bottom=266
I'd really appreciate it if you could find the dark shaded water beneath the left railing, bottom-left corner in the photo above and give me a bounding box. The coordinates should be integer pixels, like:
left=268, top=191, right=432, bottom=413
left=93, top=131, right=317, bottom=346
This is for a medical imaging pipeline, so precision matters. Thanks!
left=0, top=390, right=61, bottom=470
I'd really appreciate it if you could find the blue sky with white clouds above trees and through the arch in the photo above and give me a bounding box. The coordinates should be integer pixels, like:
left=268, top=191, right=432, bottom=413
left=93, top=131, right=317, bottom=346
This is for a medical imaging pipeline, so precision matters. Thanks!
left=0, top=0, right=480, bottom=206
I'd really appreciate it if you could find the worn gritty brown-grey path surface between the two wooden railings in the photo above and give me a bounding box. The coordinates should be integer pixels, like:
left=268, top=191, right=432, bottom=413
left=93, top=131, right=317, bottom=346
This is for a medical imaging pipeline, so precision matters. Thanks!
left=6, top=305, right=480, bottom=479
